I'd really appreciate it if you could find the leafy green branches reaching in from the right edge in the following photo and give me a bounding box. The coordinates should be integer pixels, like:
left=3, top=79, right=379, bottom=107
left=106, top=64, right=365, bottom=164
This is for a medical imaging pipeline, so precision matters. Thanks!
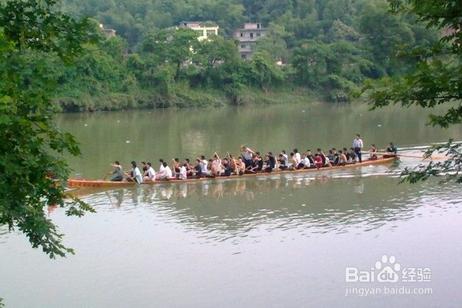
left=364, top=0, right=462, bottom=183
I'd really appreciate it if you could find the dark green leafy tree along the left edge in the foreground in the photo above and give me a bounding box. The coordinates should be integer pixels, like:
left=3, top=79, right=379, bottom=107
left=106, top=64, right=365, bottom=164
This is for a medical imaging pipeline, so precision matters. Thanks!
left=0, top=0, right=93, bottom=258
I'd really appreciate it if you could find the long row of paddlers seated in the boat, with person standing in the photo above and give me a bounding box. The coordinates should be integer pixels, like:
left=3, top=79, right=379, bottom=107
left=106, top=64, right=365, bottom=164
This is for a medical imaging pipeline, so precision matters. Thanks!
left=111, top=134, right=397, bottom=184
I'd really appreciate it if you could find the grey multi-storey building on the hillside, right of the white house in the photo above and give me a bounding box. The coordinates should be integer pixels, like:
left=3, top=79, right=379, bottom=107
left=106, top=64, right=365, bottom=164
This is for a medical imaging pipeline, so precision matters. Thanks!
left=234, top=23, right=267, bottom=59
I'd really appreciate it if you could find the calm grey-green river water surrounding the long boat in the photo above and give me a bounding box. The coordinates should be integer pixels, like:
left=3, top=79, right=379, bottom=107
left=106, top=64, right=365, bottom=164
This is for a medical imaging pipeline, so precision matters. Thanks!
left=0, top=104, right=462, bottom=307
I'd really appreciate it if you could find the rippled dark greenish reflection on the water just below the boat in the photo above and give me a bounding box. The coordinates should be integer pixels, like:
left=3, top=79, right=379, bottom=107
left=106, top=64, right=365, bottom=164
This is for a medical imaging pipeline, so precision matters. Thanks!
left=82, top=176, right=448, bottom=240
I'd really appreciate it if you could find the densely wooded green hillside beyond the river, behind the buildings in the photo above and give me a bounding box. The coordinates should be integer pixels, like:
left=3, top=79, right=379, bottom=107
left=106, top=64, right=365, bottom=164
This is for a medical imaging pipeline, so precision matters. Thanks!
left=50, top=0, right=437, bottom=111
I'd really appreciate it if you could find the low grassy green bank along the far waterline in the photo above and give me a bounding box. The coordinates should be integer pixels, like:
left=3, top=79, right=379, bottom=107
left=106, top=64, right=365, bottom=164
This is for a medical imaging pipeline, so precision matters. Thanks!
left=55, top=86, right=320, bottom=113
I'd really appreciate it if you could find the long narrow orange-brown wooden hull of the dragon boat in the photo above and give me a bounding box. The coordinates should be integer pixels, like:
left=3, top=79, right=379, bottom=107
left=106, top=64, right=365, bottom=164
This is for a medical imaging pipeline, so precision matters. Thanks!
left=67, top=156, right=397, bottom=188
